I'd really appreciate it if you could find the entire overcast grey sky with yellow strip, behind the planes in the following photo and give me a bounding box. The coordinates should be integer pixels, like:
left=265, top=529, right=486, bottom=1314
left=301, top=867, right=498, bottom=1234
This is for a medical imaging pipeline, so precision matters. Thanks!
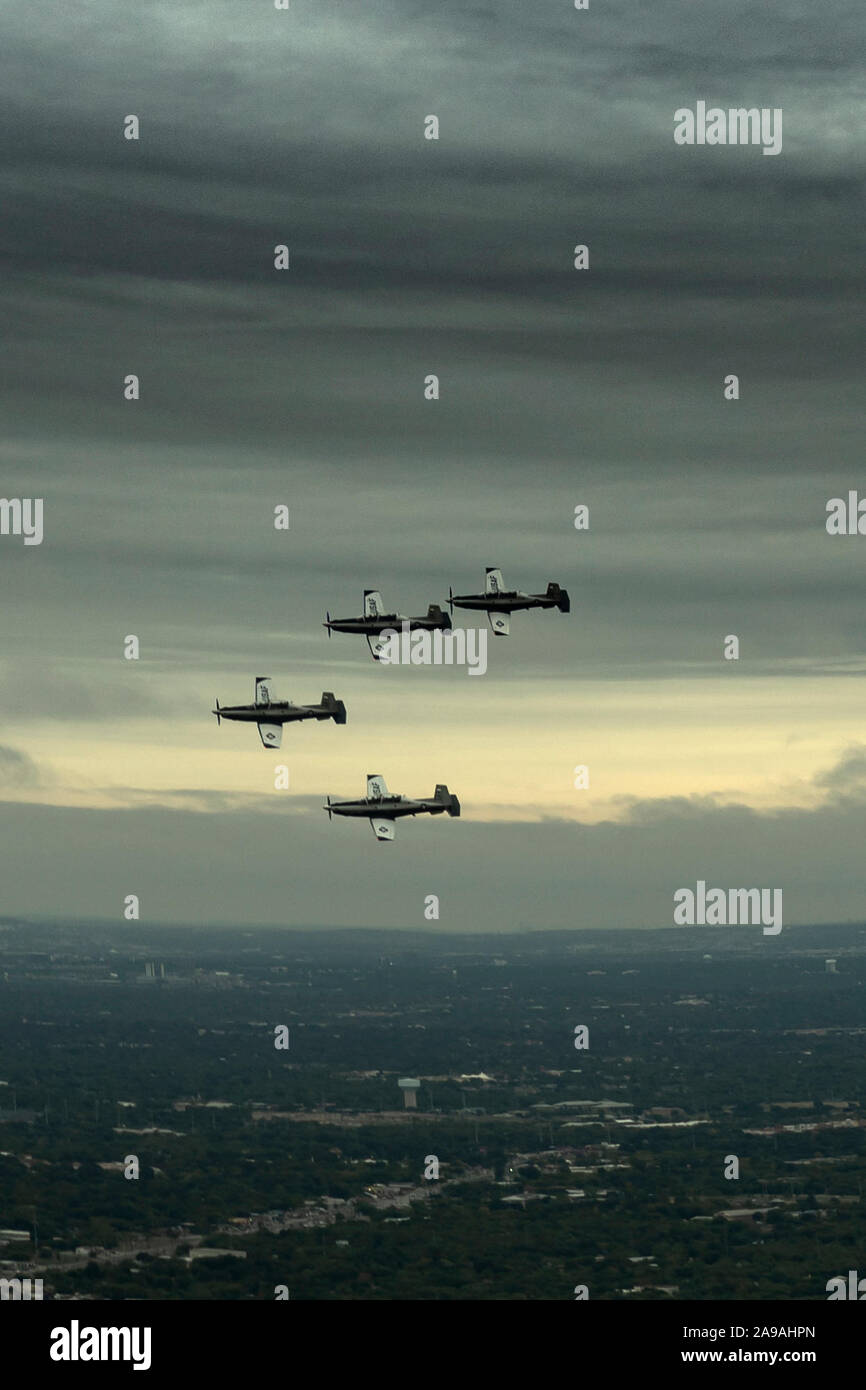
left=0, top=0, right=866, bottom=930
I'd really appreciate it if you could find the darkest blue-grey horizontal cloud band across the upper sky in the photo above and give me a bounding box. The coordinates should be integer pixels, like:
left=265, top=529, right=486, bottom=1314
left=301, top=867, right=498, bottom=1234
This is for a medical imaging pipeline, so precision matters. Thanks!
left=0, top=135, right=862, bottom=307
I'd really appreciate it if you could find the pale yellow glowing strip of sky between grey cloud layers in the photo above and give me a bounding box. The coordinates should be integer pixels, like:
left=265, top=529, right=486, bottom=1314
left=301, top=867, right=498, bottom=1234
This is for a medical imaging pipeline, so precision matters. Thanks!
left=4, top=671, right=863, bottom=821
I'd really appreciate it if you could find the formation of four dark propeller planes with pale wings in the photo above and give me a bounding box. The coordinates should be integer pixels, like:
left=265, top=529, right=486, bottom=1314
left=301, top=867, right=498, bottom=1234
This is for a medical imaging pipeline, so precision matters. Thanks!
left=213, top=569, right=571, bottom=840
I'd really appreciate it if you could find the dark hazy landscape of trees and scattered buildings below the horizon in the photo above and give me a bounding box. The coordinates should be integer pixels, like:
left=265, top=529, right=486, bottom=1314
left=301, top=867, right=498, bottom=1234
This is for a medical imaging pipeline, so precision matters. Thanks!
left=0, top=919, right=866, bottom=1300
